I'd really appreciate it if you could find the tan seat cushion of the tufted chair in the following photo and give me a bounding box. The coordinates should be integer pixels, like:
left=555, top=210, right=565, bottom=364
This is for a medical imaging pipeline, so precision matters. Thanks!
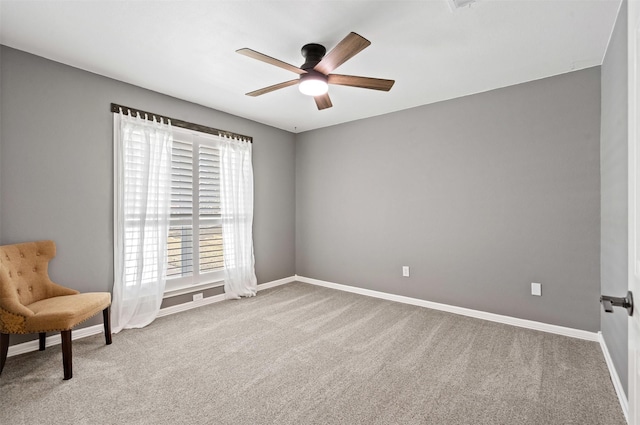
left=24, top=292, right=111, bottom=333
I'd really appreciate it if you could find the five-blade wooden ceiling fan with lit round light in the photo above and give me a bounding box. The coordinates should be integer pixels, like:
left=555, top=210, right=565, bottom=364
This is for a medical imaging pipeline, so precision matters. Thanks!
left=236, top=32, right=395, bottom=110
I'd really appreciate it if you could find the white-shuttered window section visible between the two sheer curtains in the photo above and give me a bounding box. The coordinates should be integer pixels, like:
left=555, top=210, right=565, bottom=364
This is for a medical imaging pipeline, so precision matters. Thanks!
left=165, top=128, right=224, bottom=292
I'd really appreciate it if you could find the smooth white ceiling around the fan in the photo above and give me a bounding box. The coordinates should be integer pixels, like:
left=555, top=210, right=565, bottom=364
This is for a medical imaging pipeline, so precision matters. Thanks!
left=0, top=0, right=620, bottom=132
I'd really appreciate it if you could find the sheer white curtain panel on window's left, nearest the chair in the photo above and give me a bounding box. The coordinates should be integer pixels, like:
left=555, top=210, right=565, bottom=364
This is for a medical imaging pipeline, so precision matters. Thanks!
left=111, top=112, right=173, bottom=332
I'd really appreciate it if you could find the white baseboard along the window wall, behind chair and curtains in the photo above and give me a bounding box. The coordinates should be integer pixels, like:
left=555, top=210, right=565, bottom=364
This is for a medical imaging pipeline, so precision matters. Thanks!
left=7, top=276, right=295, bottom=357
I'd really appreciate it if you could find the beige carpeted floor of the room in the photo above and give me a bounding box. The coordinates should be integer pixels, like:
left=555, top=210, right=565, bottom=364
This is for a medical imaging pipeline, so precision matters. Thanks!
left=0, top=283, right=625, bottom=425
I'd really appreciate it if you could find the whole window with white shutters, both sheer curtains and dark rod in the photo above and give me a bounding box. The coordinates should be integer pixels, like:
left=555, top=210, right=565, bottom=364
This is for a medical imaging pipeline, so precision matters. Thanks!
left=111, top=104, right=257, bottom=332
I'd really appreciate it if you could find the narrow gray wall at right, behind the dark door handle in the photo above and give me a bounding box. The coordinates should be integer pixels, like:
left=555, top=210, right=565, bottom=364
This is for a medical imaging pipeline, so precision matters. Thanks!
left=600, top=2, right=628, bottom=392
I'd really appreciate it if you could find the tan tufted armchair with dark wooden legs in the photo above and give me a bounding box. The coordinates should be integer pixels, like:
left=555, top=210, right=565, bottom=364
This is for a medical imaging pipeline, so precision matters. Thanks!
left=0, top=241, right=111, bottom=380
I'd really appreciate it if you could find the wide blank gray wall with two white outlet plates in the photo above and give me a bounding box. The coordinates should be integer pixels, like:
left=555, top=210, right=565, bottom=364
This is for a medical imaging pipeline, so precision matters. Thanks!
left=296, top=67, right=600, bottom=331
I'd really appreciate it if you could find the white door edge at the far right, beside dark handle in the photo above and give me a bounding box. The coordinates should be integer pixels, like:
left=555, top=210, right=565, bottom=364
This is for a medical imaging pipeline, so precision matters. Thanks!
left=627, top=0, right=640, bottom=425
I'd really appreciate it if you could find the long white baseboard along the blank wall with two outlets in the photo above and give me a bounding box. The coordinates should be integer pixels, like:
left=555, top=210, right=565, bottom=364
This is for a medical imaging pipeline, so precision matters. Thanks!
left=295, top=275, right=599, bottom=342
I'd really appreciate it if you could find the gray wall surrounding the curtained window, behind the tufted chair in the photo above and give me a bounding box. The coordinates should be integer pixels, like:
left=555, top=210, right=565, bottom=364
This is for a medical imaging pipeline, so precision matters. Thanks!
left=0, top=46, right=295, bottom=343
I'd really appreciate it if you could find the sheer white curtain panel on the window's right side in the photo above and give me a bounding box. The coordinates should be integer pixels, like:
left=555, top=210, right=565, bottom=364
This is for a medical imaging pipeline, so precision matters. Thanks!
left=220, top=137, right=258, bottom=299
